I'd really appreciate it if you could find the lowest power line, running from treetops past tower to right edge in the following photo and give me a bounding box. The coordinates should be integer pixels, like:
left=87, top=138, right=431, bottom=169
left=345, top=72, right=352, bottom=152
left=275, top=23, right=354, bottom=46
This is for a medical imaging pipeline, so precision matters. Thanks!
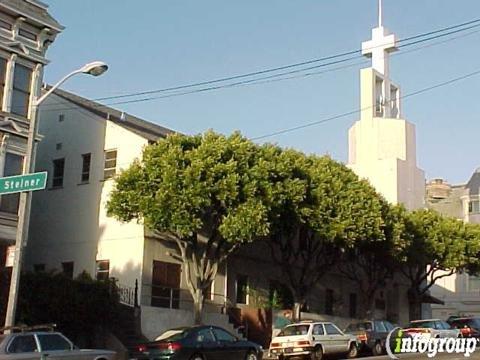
left=250, top=70, right=480, bottom=140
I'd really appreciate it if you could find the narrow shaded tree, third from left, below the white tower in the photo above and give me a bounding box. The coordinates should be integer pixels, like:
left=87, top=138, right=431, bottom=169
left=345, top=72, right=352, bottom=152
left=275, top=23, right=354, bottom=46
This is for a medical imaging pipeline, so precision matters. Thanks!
left=338, top=200, right=405, bottom=318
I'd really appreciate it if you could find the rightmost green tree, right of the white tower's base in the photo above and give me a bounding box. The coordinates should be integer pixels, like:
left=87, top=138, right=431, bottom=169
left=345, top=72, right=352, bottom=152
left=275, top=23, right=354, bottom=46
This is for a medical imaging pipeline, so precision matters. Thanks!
left=397, top=209, right=476, bottom=319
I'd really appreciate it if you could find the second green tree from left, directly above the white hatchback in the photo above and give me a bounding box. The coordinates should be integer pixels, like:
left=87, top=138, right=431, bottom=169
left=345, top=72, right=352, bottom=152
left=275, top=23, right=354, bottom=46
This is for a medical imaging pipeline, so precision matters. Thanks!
left=269, top=149, right=382, bottom=320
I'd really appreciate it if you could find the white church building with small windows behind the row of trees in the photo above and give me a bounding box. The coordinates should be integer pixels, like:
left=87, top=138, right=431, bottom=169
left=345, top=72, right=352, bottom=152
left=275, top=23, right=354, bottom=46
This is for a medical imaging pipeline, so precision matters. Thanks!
left=25, top=91, right=408, bottom=337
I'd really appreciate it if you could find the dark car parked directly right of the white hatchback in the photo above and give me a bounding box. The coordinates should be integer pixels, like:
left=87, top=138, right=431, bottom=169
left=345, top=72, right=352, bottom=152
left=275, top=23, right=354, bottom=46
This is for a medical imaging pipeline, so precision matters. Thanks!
left=344, top=320, right=395, bottom=356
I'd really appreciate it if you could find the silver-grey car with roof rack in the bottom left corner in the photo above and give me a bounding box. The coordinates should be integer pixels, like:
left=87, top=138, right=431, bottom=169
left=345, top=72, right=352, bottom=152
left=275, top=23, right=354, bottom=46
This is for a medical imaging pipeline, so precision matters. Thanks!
left=0, top=331, right=117, bottom=360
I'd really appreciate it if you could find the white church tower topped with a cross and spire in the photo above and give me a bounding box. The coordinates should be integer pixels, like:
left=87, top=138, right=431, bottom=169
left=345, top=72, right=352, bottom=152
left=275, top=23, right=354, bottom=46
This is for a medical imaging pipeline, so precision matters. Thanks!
left=348, top=0, right=425, bottom=210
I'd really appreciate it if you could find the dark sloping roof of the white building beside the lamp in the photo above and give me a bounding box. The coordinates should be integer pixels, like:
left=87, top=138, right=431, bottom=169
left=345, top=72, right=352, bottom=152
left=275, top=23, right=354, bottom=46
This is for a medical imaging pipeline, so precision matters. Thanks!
left=47, top=89, right=174, bottom=141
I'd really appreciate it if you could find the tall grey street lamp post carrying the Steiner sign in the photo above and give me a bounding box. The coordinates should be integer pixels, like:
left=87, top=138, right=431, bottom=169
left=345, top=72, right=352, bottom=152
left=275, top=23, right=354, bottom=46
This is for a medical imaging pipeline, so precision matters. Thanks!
left=5, top=61, right=108, bottom=327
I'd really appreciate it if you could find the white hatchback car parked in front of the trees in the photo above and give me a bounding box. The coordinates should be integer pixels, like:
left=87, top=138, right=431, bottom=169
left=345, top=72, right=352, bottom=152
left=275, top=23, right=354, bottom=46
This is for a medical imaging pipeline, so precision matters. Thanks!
left=269, top=322, right=358, bottom=360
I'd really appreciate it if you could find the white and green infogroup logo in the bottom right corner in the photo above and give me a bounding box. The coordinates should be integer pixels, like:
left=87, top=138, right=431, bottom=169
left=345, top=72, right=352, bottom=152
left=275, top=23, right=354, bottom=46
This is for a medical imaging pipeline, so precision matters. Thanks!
left=385, top=328, right=479, bottom=359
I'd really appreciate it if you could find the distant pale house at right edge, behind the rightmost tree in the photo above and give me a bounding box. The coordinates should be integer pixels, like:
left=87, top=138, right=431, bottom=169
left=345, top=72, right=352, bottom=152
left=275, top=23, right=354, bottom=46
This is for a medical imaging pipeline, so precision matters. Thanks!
left=426, top=168, right=480, bottom=318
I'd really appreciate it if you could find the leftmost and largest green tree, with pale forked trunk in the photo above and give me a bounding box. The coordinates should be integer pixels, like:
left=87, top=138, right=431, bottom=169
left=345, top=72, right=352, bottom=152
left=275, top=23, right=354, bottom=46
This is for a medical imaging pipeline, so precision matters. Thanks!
left=107, top=132, right=276, bottom=323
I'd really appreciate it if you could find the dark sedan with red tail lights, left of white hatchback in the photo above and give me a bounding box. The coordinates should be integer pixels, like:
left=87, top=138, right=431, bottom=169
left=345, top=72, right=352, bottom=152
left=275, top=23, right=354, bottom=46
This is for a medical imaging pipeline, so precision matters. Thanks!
left=131, top=326, right=263, bottom=360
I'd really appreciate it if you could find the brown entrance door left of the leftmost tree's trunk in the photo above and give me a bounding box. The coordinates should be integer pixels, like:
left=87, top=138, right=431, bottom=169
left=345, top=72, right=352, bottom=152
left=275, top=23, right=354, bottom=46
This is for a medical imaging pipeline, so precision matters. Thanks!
left=152, top=260, right=181, bottom=309
